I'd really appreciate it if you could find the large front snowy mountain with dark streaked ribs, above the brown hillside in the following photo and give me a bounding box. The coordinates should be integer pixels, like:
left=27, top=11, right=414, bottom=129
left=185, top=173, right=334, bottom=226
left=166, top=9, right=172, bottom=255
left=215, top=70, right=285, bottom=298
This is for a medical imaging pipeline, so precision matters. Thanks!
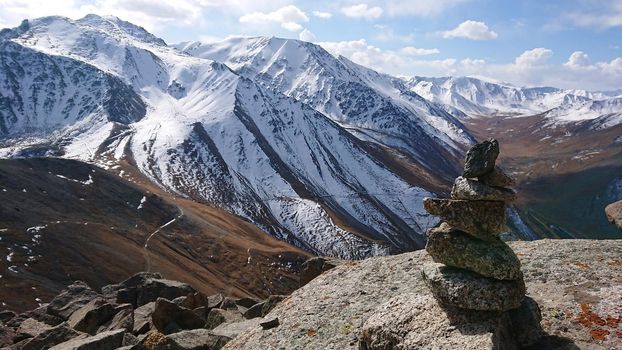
left=0, top=15, right=448, bottom=258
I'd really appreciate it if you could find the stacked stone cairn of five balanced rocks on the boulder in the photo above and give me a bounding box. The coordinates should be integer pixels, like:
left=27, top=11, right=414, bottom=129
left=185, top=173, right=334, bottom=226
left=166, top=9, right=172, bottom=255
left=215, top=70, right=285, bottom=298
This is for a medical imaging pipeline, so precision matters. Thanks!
left=423, top=139, right=537, bottom=312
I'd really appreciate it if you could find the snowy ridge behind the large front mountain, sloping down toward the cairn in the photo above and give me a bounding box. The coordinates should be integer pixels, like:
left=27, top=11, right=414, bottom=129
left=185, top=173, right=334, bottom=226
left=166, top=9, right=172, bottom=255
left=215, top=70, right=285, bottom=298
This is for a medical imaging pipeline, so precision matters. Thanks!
left=176, top=37, right=473, bottom=174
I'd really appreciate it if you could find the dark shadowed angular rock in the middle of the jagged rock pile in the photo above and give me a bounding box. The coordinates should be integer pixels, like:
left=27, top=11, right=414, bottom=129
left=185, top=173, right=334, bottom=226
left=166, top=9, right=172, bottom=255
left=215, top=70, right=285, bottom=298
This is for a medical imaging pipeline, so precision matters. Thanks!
left=151, top=298, right=205, bottom=334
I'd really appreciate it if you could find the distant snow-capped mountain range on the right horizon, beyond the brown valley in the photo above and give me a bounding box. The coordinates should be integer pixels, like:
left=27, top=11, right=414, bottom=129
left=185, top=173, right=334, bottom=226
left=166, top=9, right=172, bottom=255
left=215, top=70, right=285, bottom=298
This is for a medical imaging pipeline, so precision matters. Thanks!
left=405, top=77, right=622, bottom=122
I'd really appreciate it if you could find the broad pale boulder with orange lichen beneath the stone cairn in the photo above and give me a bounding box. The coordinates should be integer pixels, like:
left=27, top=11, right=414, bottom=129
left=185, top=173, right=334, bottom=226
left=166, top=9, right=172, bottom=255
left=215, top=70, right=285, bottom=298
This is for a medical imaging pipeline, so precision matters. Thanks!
left=225, top=240, right=622, bottom=350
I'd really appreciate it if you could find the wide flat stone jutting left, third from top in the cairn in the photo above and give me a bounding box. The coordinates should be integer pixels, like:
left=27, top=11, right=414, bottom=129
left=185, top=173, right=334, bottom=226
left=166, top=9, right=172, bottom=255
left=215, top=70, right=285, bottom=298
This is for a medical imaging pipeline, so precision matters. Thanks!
left=423, top=198, right=506, bottom=239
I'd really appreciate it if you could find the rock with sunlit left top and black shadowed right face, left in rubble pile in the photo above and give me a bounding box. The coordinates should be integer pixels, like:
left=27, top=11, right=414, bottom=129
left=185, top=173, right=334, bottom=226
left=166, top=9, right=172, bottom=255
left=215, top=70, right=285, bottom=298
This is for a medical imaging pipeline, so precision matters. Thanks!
left=67, top=298, right=115, bottom=335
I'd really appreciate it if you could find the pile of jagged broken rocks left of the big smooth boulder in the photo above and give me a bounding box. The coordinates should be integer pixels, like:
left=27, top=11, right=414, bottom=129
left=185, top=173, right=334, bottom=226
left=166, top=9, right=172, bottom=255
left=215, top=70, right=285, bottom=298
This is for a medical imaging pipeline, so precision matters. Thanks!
left=0, top=273, right=285, bottom=350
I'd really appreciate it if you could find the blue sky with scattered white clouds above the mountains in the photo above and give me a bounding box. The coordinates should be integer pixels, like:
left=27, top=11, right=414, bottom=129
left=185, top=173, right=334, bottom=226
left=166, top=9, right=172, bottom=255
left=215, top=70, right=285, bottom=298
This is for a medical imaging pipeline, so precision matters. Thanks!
left=0, top=0, right=622, bottom=90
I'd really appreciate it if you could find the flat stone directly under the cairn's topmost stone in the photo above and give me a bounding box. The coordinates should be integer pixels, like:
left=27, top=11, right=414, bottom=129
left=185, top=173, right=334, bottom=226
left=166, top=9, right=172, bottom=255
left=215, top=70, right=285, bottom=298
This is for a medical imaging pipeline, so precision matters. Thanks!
left=451, top=176, right=516, bottom=202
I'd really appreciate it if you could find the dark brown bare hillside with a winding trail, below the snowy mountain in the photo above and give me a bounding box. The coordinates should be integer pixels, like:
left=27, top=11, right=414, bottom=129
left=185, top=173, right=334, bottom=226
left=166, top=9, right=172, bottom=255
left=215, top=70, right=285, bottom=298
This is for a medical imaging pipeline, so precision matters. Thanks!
left=0, top=158, right=309, bottom=311
